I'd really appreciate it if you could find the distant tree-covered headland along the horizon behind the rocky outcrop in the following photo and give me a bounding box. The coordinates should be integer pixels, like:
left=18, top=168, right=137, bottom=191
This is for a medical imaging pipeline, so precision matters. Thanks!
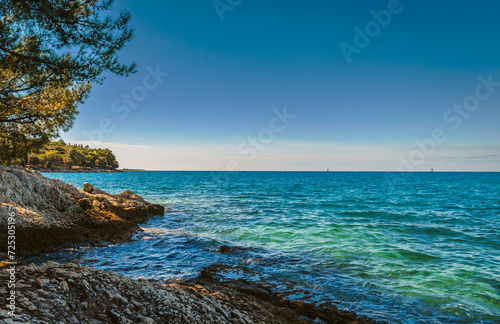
left=25, top=139, right=118, bottom=170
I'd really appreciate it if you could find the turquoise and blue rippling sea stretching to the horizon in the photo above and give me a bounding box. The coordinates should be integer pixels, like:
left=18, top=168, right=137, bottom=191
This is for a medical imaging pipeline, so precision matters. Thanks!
left=40, top=172, right=500, bottom=323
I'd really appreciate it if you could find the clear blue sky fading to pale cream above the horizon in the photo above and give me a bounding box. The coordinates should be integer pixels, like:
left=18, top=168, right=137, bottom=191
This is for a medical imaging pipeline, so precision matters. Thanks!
left=61, top=0, right=500, bottom=171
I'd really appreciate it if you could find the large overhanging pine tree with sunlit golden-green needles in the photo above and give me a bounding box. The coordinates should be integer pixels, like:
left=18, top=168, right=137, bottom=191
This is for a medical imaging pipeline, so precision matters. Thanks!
left=0, top=0, right=135, bottom=163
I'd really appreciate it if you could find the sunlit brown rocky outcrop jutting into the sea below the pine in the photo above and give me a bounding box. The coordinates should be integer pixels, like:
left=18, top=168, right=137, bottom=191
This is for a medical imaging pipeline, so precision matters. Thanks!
left=0, top=167, right=164, bottom=256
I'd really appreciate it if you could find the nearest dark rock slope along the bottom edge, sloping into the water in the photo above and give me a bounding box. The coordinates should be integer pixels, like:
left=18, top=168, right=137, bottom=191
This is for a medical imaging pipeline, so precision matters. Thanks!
left=0, top=261, right=380, bottom=324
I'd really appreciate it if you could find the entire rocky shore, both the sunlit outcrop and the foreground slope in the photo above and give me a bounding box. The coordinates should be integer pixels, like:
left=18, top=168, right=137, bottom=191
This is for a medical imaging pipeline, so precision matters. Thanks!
left=0, top=167, right=382, bottom=324
